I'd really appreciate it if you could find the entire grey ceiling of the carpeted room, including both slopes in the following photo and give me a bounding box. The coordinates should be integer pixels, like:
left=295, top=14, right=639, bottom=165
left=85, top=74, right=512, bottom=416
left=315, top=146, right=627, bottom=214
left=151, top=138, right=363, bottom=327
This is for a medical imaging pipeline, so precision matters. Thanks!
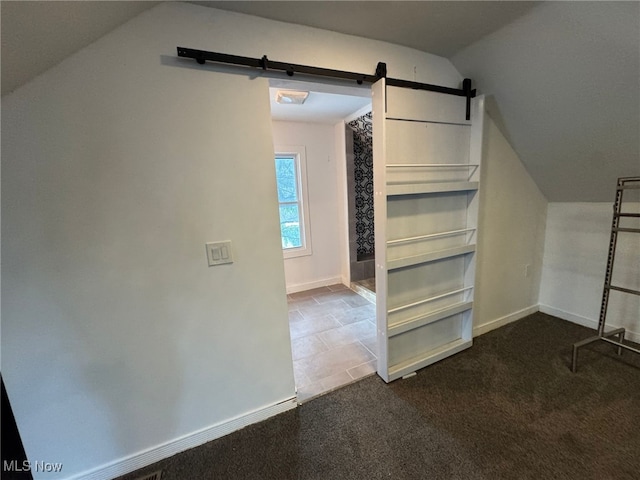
left=0, top=1, right=640, bottom=201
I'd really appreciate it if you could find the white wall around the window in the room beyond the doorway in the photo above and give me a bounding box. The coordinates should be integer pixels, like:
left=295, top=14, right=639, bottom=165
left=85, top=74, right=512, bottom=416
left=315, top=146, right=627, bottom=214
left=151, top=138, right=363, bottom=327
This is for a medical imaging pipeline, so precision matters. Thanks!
left=273, top=122, right=344, bottom=292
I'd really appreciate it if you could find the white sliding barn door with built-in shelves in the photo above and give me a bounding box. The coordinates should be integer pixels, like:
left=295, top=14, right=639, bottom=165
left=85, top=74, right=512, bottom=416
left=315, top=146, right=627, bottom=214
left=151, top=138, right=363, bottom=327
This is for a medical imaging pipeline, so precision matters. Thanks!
left=373, top=79, right=484, bottom=382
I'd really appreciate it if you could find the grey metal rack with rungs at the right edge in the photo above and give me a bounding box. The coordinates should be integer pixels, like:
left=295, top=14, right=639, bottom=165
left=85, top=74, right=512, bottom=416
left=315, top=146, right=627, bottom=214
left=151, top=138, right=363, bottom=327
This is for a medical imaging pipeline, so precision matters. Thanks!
left=571, top=177, right=640, bottom=373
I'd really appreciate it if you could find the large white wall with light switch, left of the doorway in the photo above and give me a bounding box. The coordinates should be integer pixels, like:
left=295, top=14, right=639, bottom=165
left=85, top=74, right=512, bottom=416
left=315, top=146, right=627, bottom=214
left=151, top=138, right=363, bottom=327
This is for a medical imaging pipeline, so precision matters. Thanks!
left=2, top=3, right=470, bottom=479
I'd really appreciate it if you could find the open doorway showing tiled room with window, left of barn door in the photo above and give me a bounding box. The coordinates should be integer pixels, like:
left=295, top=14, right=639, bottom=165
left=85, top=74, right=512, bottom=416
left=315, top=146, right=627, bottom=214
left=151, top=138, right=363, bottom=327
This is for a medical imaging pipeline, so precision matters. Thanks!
left=270, top=80, right=377, bottom=402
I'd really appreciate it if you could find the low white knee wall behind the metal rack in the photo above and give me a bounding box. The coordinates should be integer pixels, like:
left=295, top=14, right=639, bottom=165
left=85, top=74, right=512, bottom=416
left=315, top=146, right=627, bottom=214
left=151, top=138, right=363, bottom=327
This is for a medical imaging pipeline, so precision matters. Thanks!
left=540, top=202, right=640, bottom=341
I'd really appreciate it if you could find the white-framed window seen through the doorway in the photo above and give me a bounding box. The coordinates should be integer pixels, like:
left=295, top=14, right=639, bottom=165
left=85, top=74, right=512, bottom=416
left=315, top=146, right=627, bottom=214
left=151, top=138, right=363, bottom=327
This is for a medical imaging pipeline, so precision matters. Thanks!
left=275, top=147, right=311, bottom=258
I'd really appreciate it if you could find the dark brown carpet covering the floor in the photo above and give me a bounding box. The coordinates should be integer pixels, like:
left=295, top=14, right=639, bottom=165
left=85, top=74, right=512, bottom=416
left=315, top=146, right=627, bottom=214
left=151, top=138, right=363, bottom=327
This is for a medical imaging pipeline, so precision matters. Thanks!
left=123, top=313, right=640, bottom=480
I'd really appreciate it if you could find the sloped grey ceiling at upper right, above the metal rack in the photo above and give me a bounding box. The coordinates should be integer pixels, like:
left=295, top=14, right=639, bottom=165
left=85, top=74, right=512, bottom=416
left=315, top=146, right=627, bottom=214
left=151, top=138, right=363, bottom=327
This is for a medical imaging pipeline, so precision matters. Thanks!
left=451, top=2, right=640, bottom=202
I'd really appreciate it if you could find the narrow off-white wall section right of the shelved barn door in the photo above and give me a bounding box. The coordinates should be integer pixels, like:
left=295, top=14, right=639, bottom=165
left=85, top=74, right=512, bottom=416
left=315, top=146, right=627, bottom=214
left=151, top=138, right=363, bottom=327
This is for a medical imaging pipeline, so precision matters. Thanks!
left=474, top=115, right=547, bottom=335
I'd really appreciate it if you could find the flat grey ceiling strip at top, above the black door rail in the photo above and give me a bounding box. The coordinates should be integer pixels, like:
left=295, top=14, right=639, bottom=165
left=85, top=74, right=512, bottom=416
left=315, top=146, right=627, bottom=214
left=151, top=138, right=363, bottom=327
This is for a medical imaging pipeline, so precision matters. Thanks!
left=189, top=1, right=540, bottom=58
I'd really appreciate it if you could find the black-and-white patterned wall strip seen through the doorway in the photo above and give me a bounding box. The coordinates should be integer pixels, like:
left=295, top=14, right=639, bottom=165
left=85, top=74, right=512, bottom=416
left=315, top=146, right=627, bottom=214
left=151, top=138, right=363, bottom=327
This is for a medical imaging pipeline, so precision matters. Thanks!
left=349, top=112, right=375, bottom=259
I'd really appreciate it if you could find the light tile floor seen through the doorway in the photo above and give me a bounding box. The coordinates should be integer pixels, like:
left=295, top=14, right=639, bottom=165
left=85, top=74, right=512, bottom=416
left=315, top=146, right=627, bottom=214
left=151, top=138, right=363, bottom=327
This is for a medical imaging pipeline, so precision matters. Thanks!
left=287, top=285, right=377, bottom=402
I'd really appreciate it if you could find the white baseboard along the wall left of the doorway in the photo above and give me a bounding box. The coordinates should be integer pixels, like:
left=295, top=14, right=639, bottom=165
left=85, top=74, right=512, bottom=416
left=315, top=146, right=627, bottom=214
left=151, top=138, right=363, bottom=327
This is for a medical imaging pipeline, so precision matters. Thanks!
left=68, top=397, right=298, bottom=480
